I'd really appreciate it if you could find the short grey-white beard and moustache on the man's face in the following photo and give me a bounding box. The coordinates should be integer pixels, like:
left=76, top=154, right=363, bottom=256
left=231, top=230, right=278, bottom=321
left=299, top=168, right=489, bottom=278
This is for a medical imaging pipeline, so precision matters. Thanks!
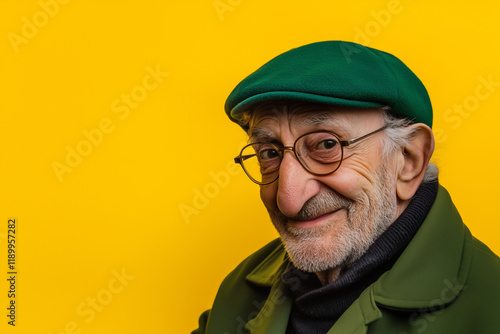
left=269, top=166, right=397, bottom=273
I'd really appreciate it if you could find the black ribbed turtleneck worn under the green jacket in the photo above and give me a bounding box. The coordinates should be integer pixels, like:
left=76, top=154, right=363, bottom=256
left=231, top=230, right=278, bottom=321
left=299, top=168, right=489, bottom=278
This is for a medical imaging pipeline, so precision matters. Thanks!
left=283, top=182, right=438, bottom=334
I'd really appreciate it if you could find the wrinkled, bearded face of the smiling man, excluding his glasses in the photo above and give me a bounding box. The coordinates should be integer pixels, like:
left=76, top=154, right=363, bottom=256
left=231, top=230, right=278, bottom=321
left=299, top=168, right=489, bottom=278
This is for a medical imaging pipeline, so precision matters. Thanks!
left=250, top=108, right=396, bottom=272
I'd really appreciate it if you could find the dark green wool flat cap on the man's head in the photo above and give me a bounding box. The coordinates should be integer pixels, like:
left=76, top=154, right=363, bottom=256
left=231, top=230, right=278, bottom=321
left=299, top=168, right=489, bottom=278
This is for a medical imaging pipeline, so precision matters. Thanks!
left=225, top=41, right=432, bottom=127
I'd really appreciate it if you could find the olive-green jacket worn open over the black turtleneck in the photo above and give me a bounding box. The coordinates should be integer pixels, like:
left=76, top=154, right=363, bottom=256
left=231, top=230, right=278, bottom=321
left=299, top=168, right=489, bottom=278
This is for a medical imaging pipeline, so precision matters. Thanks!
left=193, top=187, right=500, bottom=334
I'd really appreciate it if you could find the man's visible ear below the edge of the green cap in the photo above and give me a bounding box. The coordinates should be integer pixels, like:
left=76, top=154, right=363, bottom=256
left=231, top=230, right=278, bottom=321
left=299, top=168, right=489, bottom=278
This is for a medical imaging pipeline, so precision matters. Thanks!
left=396, top=123, right=434, bottom=201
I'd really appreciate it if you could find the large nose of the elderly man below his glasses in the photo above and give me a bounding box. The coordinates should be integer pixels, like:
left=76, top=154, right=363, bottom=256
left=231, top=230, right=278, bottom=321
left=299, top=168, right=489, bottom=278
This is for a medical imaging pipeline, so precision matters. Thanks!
left=276, top=150, right=319, bottom=217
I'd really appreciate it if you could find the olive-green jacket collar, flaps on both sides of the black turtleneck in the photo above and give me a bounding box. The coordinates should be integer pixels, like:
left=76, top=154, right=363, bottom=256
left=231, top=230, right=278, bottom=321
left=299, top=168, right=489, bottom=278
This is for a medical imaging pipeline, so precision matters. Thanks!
left=246, top=186, right=472, bottom=311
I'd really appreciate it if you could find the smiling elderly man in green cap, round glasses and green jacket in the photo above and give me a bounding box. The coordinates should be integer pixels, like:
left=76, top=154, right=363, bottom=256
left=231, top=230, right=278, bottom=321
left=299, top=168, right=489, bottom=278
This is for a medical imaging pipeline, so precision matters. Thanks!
left=193, top=41, right=500, bottom=334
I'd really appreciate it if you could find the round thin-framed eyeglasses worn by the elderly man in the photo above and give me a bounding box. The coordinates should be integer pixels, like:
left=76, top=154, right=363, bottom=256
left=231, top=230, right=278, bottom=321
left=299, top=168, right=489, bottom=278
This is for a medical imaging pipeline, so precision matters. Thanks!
left=234, top=125, right=387, bottom=185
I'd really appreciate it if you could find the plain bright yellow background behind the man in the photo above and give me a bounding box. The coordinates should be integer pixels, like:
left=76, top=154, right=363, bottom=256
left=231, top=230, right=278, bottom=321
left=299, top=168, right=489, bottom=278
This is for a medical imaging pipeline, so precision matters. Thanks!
left=0, top=0, right=500, bottom=334
